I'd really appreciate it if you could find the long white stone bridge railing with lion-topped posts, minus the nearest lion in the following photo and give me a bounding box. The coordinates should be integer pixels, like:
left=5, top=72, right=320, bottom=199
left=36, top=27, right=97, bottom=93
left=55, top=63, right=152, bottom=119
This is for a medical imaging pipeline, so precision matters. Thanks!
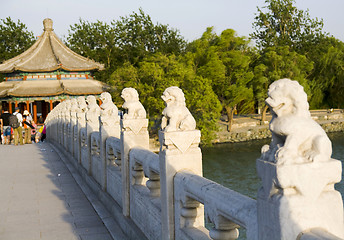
left=46, top=81, right=344, bottom=240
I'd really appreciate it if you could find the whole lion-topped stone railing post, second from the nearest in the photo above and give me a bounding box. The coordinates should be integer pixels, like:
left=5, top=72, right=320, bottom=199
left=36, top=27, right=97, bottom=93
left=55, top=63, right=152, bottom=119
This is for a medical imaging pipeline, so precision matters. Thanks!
left=159, top=87, right=204, bottom=239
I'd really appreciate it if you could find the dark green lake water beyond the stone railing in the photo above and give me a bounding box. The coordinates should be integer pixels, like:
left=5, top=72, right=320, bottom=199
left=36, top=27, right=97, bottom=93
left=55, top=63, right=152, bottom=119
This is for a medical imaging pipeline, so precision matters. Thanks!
left=202, top=132, right=344, bottom=239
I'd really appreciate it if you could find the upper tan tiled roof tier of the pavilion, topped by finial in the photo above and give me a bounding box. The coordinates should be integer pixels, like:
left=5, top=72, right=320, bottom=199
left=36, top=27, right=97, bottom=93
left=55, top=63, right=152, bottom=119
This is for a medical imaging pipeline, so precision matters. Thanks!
left=0, top=18, right=104, bottom=73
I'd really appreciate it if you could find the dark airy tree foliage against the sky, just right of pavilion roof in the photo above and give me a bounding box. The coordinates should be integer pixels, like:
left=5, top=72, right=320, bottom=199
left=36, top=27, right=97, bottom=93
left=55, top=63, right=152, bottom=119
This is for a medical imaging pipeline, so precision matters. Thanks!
left=67, top=9, right=185, bottom=82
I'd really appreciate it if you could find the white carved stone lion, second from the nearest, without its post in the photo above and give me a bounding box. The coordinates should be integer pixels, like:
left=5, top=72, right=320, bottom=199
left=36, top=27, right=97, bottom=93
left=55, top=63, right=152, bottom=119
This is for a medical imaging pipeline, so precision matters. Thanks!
left=161, top=87, right=196, bottom=132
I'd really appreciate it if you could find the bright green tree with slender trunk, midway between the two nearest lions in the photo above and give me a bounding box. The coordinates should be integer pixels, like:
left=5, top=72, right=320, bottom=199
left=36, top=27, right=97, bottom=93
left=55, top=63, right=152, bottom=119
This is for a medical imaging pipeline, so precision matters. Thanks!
left=187, top=28, right=254, bottom=131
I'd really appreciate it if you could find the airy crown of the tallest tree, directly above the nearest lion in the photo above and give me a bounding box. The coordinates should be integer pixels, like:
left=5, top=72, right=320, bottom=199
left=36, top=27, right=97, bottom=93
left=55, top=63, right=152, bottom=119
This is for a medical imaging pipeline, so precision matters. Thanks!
left=251, top=0, right=324, bottom=51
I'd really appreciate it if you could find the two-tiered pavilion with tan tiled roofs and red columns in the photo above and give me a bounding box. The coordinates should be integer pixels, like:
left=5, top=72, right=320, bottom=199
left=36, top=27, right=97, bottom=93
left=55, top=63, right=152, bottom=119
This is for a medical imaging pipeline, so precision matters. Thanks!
left=0, top=18, right=107, bottom=122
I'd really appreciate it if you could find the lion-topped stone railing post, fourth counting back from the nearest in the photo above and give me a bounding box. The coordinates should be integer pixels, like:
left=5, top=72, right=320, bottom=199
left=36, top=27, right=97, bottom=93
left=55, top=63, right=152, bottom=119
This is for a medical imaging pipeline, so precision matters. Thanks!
left=99, top=92, right=121, bottom=191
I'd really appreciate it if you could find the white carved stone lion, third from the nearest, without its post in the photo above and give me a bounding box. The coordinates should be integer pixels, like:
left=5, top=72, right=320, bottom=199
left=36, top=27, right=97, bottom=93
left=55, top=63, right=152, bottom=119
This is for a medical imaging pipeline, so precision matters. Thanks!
left=121, top=88, right=146, bottom=119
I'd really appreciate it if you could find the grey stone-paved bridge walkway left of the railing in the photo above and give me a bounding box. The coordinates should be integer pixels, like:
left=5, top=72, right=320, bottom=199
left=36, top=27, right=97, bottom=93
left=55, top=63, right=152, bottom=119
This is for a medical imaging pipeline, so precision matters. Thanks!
left=0, top=143, right=119, bottom=240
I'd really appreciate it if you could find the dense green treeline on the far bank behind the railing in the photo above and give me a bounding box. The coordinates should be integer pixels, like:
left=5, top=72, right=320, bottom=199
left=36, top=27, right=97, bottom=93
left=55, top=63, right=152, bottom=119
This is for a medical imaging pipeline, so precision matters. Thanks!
left=0, top=0, right=344, bottom=142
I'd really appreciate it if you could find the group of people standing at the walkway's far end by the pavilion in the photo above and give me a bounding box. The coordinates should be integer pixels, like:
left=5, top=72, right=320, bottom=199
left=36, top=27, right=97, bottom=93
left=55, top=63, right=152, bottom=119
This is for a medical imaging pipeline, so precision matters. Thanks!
left=0, top=107, right=46, bottom=145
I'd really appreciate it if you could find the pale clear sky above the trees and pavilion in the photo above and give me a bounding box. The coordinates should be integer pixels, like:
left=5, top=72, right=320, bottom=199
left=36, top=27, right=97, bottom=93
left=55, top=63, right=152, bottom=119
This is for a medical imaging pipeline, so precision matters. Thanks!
left=0, top=0, right=344, bottom=41
